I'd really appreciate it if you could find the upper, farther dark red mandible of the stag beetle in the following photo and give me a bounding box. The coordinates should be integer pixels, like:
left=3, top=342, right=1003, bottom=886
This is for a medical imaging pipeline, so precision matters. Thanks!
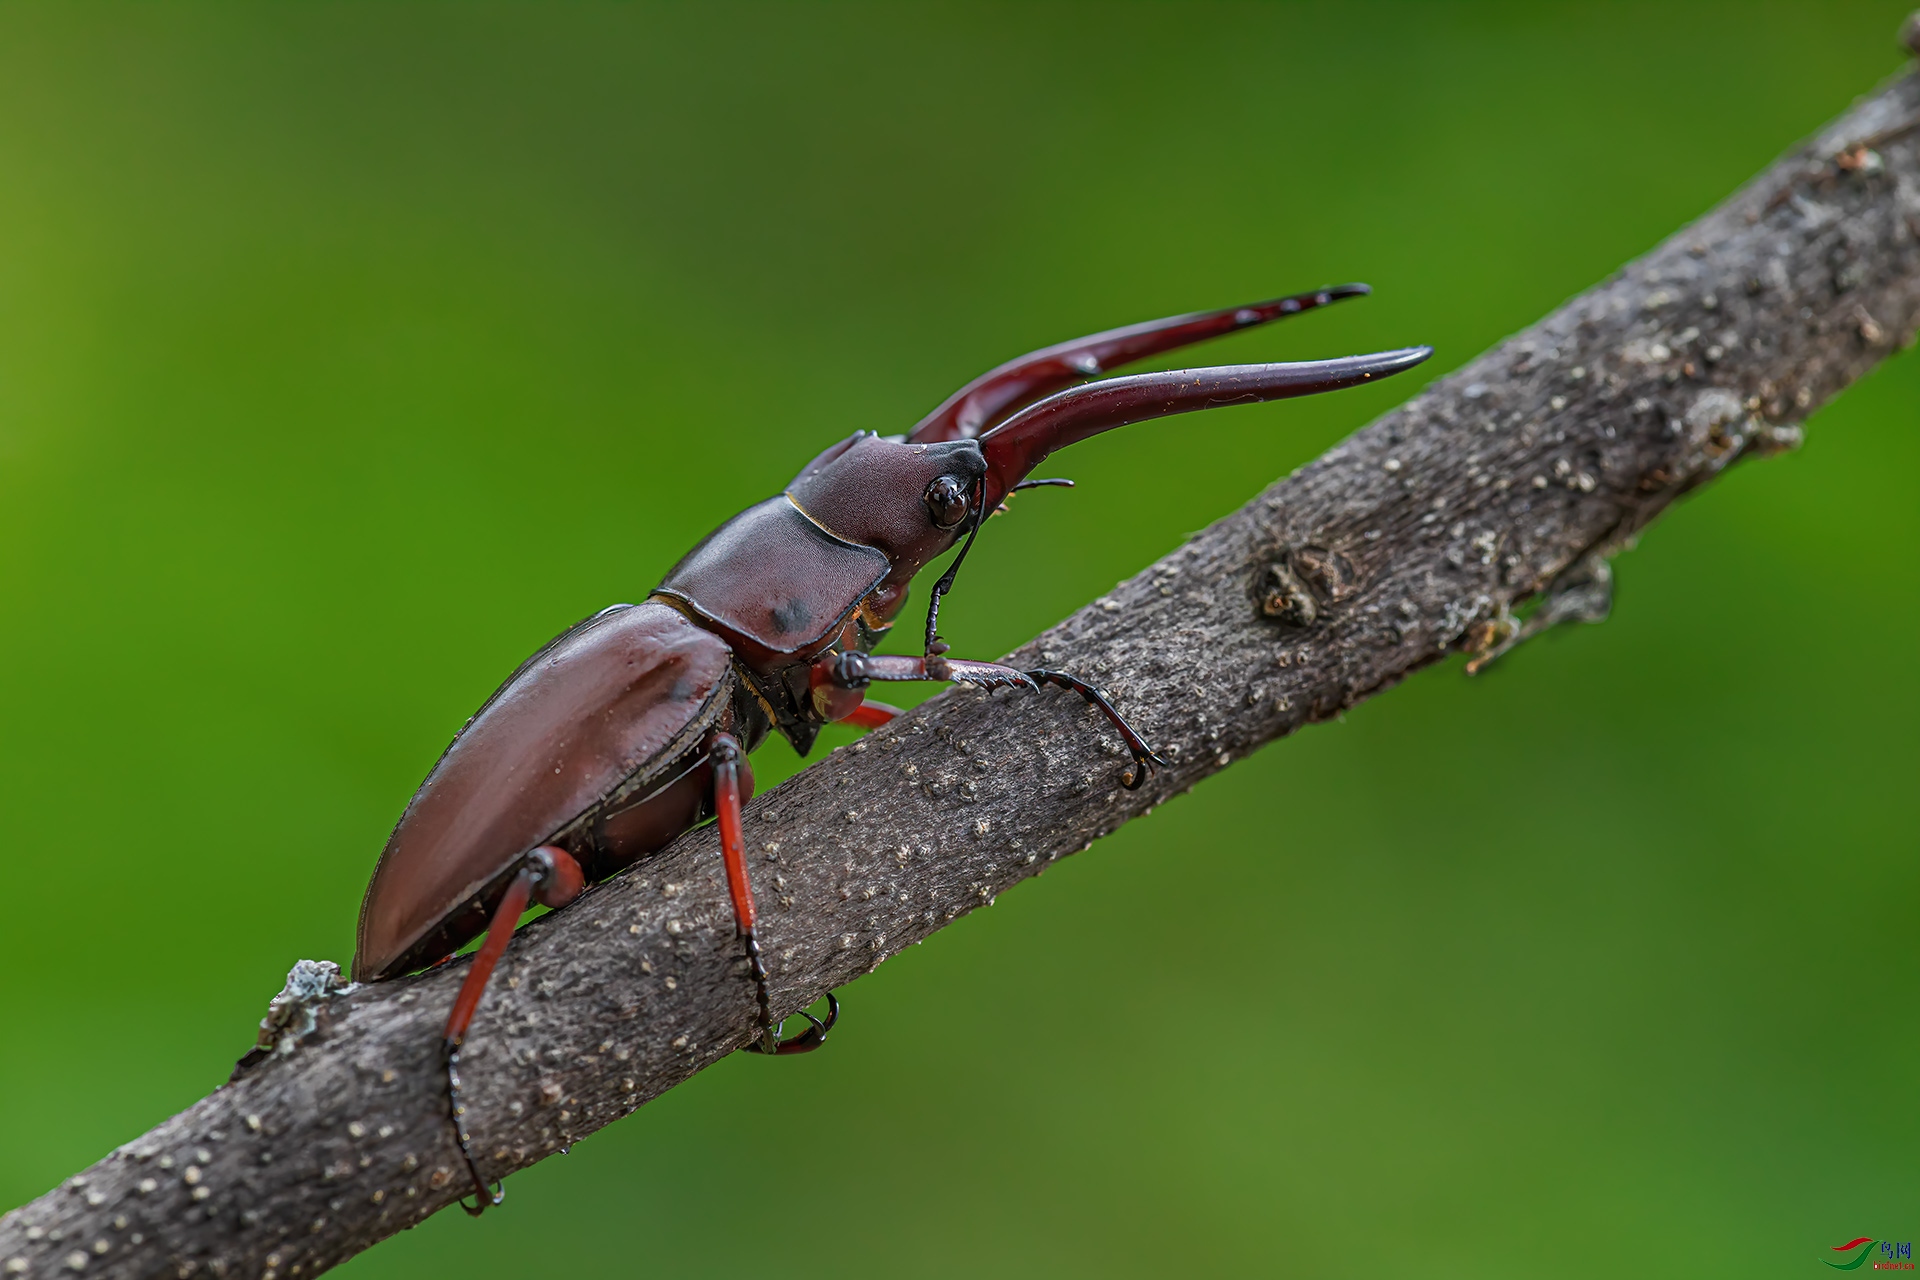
left=906, top=284, right=1373, bottom=443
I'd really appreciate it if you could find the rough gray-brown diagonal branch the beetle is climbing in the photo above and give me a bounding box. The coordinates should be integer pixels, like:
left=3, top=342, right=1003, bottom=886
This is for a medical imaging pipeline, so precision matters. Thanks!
left=0, top=47, right=1920, bottom=1276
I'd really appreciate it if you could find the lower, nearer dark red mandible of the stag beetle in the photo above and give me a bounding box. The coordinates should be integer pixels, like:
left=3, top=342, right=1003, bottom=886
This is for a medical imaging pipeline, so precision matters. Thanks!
left=979, top=347, right=1434, bottom=510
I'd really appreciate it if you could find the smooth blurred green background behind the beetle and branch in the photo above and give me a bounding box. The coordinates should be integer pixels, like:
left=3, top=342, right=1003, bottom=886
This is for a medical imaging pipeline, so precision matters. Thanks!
left=0, top=0, right=1920, bottom=1278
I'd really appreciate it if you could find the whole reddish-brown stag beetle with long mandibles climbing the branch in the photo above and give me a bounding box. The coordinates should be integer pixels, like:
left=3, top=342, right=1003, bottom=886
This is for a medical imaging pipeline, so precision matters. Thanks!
left=353, top=284, right=1430, bottom=1215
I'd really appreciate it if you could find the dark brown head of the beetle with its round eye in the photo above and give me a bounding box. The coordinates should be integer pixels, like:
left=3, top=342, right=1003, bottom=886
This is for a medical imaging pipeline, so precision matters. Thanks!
left=787, top=432, right=987, bottom=616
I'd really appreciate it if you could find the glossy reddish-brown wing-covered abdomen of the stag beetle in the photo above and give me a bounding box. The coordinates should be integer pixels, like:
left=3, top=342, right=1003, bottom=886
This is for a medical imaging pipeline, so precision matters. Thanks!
left=353, top=603, right=733, bottom=981
